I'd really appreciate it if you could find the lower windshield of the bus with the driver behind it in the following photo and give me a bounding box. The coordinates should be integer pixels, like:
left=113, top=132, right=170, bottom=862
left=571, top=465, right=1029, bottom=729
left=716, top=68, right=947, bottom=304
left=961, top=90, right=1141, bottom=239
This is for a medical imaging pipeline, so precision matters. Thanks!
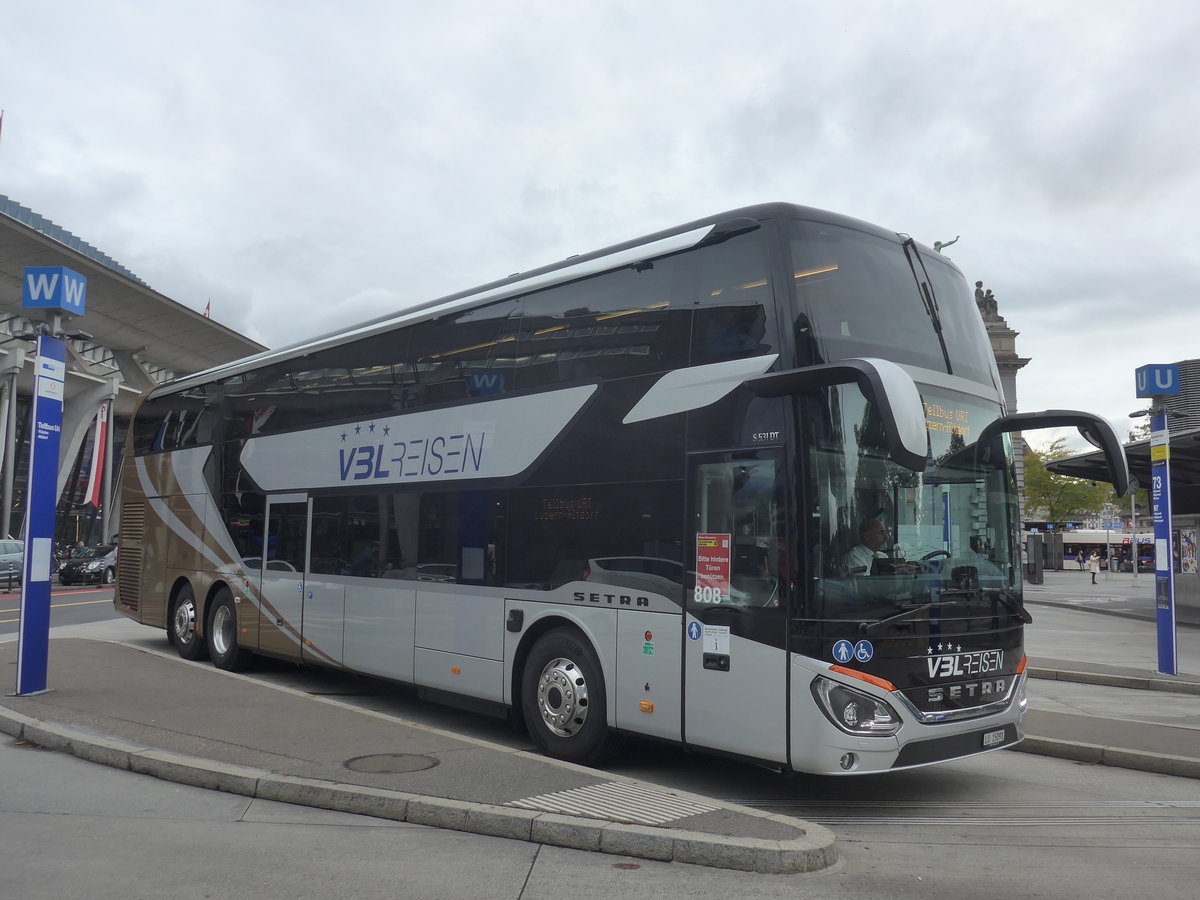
left=811, top=386, right=1020, bottom=620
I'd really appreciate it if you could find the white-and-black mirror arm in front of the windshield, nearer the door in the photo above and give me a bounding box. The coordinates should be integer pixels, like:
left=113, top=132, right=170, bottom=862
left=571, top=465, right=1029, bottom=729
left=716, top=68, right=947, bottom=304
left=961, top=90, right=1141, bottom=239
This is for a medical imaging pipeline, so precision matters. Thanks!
left=746, top=358, right=929, bottom=472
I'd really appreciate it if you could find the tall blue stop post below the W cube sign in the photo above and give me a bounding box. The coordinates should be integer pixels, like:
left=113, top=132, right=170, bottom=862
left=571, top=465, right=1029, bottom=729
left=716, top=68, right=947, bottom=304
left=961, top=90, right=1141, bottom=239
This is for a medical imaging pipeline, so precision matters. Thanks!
left=17, top=338, right=67, bottom=696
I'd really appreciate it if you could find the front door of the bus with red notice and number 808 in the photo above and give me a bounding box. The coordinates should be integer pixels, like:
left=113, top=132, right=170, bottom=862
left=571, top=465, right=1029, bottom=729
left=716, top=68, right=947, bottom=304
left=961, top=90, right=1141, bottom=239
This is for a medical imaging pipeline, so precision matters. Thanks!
left=684, top=450, right=790, bottom=763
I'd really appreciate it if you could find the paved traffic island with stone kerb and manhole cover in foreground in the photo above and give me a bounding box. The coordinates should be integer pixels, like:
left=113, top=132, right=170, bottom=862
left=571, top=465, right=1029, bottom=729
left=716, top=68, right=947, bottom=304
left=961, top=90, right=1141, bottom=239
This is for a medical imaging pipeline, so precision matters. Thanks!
left=0, top=638, right=838, bottom=874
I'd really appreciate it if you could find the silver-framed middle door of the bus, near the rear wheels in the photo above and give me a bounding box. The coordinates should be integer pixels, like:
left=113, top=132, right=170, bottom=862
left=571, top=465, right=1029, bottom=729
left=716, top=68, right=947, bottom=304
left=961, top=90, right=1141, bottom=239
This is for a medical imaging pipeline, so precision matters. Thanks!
left=258, top=493, right=310, bottom=659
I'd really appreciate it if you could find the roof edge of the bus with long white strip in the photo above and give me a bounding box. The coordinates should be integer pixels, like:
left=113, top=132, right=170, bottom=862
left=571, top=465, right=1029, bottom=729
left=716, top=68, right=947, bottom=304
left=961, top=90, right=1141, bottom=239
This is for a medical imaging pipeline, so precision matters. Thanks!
left=152, top=203, right=916, bottom=396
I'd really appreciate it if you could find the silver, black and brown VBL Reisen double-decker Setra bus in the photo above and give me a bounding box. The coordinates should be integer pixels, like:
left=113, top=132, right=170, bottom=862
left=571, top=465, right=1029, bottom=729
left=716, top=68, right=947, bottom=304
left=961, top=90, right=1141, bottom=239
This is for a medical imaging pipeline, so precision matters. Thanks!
left=114, top=204, right=1128, bottom=774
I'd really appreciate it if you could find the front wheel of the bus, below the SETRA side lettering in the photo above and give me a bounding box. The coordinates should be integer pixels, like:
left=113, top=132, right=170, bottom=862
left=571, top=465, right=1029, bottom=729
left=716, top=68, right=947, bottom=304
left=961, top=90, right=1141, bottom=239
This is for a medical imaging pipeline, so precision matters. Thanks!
left=521, top=629, right=610, bottom=764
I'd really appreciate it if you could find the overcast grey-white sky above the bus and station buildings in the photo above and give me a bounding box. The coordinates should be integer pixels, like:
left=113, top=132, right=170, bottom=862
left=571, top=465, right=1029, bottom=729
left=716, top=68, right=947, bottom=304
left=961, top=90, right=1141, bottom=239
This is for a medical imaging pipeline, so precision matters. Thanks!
left=0, top=0, right=1200, bottom=451
